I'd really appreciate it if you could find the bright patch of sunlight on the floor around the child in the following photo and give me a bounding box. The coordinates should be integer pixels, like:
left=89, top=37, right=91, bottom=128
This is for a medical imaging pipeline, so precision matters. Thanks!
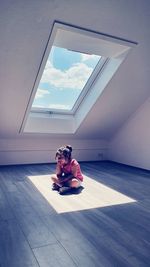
left=28, top=175, right=136, bottom=213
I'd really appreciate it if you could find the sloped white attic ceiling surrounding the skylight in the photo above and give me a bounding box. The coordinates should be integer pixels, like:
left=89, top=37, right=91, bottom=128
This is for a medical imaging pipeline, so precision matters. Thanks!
left=0, top=0, right=150, bottom=139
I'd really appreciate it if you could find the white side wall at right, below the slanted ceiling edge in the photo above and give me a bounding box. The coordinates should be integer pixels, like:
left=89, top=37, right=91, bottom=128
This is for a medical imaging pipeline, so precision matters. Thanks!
left=108, top=98, right=150, bottom=170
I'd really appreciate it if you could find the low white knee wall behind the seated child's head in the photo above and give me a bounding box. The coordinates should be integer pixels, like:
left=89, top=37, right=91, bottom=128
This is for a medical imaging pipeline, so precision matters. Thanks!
left=0, top=137, right=108, bottom=165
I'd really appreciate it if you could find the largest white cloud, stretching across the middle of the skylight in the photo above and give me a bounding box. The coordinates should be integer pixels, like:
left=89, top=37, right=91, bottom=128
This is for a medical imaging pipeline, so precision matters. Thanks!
left=41, top=61, right=93, bottom=89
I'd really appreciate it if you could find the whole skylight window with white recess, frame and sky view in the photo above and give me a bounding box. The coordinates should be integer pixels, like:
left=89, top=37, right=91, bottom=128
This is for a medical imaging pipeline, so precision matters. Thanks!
left=20, top=22, right=136, bottom=134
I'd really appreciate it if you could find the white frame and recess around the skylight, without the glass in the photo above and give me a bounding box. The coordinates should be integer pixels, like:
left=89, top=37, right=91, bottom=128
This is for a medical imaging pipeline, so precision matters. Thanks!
left=20, top=22, right=136, bottom=134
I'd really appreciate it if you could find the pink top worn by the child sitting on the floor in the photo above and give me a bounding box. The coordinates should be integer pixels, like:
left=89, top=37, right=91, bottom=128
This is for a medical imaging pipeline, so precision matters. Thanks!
left=58, top=159, right=83, bottom=181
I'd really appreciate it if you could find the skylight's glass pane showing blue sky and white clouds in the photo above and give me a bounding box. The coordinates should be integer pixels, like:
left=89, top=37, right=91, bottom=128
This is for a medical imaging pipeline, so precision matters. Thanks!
left=32, top=46, right=101, bottom=111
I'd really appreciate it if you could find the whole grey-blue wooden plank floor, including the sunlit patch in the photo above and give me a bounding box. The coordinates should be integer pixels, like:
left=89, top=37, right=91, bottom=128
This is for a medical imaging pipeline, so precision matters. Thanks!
left=0, top=162, right=150, bottom=267
